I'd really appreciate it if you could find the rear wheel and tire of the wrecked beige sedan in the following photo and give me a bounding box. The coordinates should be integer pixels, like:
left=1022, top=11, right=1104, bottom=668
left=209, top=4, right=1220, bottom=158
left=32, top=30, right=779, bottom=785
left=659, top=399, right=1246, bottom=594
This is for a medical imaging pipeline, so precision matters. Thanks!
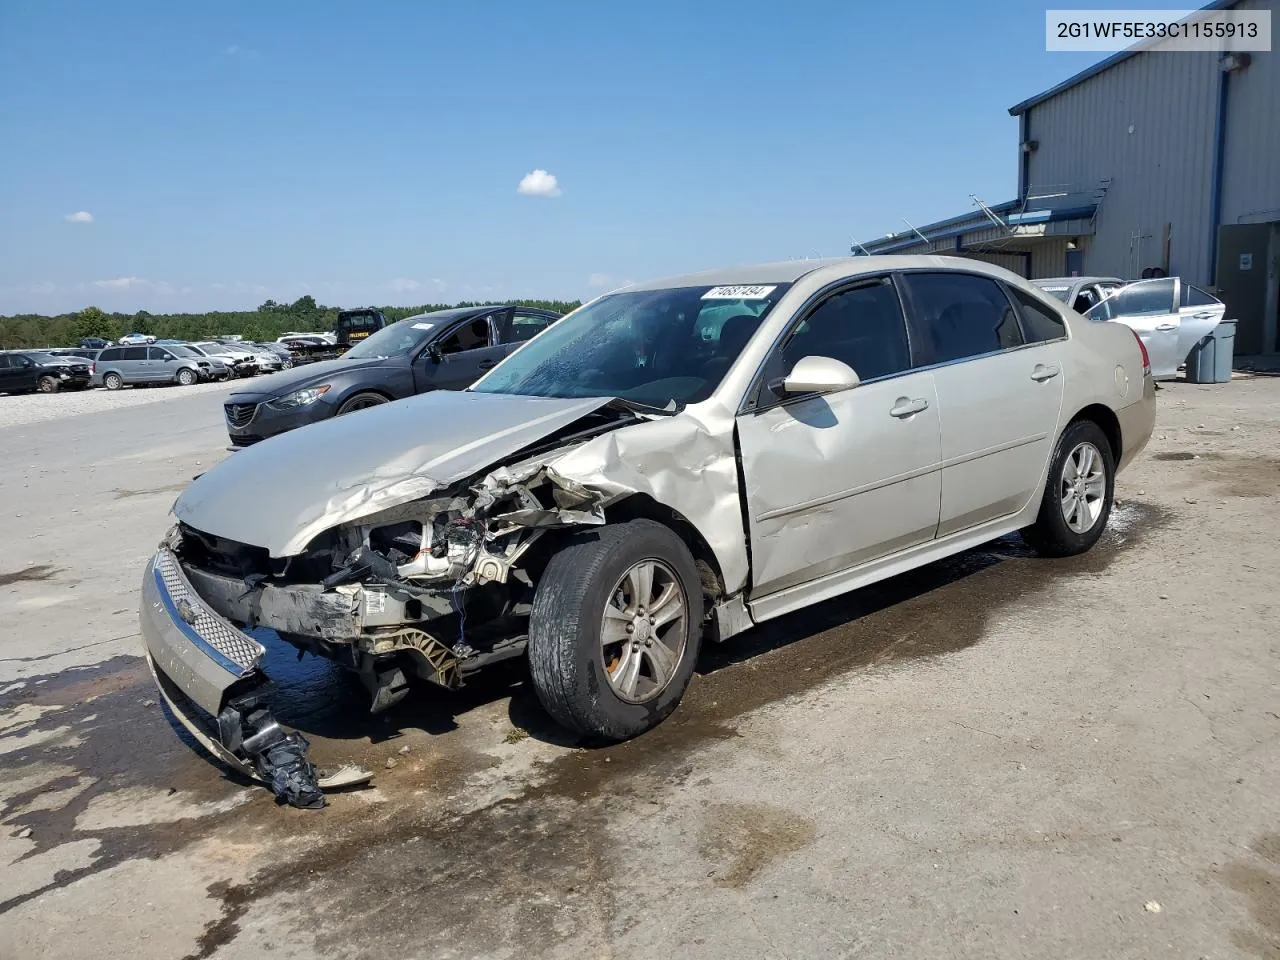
left=1021, top=420, right=1116, bottom=557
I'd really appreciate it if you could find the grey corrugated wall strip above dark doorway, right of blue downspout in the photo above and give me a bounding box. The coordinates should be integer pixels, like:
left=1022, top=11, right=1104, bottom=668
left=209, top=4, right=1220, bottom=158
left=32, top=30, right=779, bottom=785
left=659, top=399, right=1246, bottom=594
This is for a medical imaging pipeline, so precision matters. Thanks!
left=1222, top=0, right=1280, bottom=223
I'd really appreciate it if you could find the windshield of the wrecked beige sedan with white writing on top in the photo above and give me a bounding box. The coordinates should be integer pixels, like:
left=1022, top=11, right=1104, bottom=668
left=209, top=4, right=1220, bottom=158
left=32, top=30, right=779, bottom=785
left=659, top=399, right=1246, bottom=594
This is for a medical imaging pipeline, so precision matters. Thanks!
left=472, top=283, right=791, bottom=407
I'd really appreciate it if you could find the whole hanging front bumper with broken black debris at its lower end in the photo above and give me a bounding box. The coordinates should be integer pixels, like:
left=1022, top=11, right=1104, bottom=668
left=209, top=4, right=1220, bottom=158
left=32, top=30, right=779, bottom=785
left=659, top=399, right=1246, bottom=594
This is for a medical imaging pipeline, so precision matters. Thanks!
left=138, top=548, right=372, bottom=809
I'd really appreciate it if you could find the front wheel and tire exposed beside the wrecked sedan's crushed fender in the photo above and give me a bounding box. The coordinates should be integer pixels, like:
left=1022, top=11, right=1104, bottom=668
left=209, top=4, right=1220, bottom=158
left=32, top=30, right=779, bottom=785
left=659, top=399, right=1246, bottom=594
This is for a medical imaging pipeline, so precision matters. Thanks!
left=529, top=520, right=703, bottom=741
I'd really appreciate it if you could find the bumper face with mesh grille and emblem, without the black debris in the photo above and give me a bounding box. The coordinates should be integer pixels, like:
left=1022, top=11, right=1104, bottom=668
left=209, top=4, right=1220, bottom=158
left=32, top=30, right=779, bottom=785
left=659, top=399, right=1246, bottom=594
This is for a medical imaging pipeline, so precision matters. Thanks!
left=138, top=549, right=266, bottom=717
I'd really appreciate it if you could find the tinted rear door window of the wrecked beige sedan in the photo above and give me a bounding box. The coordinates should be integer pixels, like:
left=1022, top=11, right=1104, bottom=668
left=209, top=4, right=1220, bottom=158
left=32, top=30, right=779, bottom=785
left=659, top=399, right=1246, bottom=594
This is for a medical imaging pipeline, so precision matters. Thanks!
left=902, top=273, right=1023, bottom=365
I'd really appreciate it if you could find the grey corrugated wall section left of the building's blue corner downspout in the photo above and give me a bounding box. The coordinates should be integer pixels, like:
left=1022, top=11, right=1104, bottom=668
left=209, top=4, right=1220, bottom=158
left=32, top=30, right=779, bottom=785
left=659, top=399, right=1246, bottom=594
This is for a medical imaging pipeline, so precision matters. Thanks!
left=1028, top=54, right=1219, bottom=283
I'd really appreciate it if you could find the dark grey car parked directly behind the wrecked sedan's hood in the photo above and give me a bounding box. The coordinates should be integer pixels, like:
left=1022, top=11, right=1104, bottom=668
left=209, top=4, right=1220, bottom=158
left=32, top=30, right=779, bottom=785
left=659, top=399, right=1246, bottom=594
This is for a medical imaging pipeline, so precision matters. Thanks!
left=225, top=305, right=561, bottom=447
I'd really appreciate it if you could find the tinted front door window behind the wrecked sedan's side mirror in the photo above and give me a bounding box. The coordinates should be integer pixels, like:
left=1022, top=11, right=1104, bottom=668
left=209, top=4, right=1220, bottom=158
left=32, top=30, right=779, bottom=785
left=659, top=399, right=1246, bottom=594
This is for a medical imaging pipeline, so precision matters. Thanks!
left=778, top=279, right=911, bottom=380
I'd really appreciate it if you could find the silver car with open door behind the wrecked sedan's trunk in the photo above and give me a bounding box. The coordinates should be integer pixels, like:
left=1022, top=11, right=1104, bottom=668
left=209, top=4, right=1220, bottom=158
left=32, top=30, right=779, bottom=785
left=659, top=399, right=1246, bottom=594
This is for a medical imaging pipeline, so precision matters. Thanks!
left=1034, top=276, right=1226, bottom=380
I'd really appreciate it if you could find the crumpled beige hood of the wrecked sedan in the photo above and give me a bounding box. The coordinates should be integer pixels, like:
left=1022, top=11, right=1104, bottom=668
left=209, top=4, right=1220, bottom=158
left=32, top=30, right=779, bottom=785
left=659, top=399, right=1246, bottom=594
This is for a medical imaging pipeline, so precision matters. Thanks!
left=173, top=390, right=613, bottom=557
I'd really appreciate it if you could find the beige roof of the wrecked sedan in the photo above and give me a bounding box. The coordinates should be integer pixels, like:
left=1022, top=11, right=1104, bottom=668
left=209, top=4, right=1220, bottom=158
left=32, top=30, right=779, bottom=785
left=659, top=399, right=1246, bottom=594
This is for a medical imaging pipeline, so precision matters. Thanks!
left=616, top=255, right=1044, bottom=293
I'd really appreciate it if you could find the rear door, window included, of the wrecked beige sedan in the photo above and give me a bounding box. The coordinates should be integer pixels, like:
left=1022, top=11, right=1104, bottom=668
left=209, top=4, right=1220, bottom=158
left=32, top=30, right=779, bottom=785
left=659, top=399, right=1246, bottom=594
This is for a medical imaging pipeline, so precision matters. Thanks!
left=901, top=271, right=1066, bottom=538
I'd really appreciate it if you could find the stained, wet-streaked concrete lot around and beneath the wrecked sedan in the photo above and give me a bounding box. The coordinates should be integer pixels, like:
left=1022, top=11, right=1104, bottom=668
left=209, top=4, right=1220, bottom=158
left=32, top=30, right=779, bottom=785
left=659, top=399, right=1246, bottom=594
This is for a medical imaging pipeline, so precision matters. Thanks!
left=0, top=376, right=1280, bottom=960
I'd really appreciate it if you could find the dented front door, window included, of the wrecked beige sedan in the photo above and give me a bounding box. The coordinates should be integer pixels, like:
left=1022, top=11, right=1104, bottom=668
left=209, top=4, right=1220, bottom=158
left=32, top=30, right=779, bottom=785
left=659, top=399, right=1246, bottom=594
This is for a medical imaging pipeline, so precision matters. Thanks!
left=737, top=275, right=942, bottom=617
